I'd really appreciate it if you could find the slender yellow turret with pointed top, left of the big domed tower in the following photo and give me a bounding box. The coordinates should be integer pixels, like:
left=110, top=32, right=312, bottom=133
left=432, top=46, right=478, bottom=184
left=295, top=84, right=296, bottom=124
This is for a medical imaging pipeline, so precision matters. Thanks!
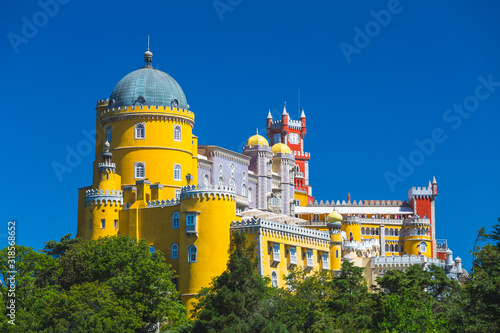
left=78, top=142, right=123, bottom=239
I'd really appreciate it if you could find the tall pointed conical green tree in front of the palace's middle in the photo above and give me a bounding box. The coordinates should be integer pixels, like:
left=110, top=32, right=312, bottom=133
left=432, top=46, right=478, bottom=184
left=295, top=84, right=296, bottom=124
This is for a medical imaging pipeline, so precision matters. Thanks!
left=193, top=232, right=286, bottom=332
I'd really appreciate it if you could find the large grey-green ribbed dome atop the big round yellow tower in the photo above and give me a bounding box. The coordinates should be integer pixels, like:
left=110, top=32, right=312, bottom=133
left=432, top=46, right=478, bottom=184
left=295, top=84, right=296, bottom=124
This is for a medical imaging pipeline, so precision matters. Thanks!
left=109, top=49, right=189, bottom=109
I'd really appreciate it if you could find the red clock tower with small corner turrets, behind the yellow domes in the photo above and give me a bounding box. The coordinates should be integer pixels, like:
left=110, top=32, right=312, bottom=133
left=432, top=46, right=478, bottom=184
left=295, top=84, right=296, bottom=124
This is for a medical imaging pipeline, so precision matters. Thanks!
left=267, top=103, right=314, bottom=203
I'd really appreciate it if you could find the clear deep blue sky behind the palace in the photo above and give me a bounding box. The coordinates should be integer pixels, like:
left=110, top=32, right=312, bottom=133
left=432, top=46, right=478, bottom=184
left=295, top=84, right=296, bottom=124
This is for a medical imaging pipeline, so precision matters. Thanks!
left=0, top=0, right=500, bottom=268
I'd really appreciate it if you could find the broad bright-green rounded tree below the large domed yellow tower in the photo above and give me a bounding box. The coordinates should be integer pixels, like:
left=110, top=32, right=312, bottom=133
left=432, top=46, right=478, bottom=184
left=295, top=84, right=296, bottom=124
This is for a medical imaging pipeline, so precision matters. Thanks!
left=59, top=236, right=186, bottom=330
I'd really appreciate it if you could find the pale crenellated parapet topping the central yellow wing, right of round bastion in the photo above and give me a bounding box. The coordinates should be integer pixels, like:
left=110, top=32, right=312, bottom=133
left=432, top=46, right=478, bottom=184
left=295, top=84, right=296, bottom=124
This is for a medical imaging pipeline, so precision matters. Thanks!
left=231, top=218, right=330, bottom=242
